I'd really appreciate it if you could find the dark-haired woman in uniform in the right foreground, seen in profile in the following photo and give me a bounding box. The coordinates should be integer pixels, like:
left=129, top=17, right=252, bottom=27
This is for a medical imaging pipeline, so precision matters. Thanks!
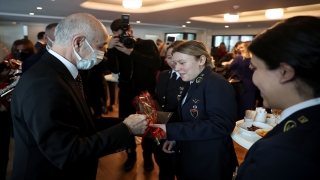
left=237, top=16, right=320, bottom=180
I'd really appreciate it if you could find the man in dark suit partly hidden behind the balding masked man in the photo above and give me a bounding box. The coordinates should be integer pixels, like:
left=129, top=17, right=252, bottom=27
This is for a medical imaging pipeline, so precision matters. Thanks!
left=22, top=23, right=58, bottom=74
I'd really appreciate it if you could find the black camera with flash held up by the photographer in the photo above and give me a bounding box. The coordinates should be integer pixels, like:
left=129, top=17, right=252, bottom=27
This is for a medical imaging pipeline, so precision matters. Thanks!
left=116, top=14, right=135, bottom=48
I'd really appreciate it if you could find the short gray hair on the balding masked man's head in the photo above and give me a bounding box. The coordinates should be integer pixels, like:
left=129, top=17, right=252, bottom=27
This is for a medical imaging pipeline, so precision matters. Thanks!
left=54, top=13, right=104, bottom=46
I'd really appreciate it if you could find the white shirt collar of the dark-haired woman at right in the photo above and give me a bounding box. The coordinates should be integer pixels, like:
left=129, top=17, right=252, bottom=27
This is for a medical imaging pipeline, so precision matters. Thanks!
left=278, top=98, right=320, bottom=124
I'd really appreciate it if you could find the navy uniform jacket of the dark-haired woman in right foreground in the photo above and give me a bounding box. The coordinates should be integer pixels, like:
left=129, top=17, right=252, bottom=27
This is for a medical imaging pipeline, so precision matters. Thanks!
left=237, top=105, right=320, bottom=180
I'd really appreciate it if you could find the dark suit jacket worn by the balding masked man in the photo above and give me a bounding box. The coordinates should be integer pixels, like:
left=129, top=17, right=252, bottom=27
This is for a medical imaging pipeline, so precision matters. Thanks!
left=11, top=52, right=131, bottom=180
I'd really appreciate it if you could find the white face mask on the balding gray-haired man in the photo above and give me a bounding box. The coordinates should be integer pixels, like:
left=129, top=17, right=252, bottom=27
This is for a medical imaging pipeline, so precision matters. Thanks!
left=72, top=39, right=104, bottom=70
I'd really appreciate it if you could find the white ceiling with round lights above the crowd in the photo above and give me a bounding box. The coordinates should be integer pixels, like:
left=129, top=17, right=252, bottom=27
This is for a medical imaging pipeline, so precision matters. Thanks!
left=0, top=0, right=320, bottom=31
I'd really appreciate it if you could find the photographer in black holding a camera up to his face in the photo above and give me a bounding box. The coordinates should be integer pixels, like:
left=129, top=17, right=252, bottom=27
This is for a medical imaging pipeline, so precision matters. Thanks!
left=107, top=15, right=160, bottom=171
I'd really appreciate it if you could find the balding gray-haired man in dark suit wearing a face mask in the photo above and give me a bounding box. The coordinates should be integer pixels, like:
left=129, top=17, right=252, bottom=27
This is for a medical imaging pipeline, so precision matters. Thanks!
left=11, top=13, right=147, bottom=180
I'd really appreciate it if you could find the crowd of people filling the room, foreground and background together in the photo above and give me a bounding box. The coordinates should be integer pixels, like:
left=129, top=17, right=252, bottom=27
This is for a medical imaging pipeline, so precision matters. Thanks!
left=0, top=13, right=320, bottom=180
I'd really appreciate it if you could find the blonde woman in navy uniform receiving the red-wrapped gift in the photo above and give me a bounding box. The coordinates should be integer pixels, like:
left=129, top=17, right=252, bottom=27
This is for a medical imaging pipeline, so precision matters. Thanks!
left=154, top=40, right=238, bottom=180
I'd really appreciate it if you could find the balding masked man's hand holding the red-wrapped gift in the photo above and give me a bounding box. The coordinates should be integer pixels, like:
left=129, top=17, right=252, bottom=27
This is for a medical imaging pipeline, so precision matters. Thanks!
left=123, top=114, right=148, bottom=135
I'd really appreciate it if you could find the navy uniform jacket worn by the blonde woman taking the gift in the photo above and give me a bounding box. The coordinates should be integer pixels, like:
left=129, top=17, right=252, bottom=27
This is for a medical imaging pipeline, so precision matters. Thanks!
left=166, top=67, right=237, bottom=180
